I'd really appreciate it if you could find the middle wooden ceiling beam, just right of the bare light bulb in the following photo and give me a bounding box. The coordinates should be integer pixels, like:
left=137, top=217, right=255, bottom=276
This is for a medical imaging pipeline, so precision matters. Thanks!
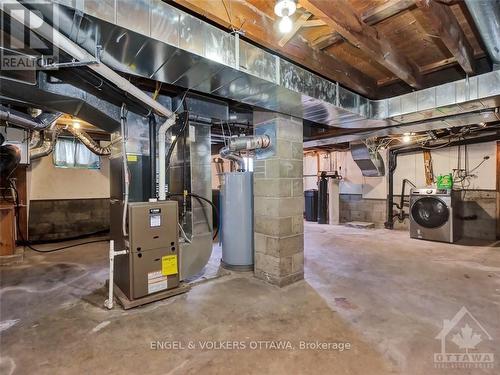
left=301, top=0, right=421, bottom=88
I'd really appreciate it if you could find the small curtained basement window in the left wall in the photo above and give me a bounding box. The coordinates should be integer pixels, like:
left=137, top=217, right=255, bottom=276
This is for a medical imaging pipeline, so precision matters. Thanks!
left=52, top=137, right=101, bottom=169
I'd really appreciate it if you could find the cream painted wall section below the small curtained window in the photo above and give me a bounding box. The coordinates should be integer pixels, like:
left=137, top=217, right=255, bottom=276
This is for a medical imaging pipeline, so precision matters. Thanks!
left=28, top=155, right=109, bottom=200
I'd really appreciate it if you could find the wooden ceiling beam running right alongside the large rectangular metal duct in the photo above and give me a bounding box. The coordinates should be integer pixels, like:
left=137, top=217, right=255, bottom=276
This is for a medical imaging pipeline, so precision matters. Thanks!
left=173, top=0, right=377, bottom=98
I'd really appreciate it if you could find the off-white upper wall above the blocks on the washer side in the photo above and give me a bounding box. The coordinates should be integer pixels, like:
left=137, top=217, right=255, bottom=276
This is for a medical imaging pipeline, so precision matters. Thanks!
left=304, top=142, right=496, bottom=199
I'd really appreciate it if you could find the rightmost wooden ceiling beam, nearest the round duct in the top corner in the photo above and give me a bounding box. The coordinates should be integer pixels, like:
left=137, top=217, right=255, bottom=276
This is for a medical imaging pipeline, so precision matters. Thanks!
left=416, top=0, right=475, bottom=74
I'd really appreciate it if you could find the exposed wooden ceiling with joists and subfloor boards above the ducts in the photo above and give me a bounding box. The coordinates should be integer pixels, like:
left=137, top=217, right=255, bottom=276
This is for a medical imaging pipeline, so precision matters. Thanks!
left=169, top=0, right=488, bottom=98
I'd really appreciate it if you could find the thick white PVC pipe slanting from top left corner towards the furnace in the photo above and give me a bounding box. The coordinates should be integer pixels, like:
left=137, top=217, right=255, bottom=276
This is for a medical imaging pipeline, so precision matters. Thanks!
left=0, top=0, right=173, bottom=117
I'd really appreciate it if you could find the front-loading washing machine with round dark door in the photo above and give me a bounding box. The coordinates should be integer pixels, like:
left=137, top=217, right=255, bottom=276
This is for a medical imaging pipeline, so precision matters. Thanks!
left=410, top=188, right=462, bottom=243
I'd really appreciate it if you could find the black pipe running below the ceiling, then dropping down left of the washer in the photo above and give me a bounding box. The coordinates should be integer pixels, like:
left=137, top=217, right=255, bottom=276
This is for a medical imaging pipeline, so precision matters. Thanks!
left=384, top=131, right=500, bottom=229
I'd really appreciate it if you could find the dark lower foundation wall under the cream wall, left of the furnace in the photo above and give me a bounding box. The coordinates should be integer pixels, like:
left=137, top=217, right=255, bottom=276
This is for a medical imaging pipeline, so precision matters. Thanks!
left=28, top=198, right=109, bottom=241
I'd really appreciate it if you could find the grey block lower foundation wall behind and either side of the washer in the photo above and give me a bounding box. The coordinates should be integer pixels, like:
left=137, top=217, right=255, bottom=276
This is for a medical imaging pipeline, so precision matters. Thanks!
left=340, top=190, right=497, bottom=240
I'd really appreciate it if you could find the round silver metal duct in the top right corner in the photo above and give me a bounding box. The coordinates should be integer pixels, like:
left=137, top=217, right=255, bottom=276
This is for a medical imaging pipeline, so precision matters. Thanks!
left=465, top=0, right=500, bottom=70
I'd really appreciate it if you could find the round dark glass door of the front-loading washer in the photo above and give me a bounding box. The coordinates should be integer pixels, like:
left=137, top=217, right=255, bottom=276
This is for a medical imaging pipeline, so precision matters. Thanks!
left=411, top=197, right=450, bottom=229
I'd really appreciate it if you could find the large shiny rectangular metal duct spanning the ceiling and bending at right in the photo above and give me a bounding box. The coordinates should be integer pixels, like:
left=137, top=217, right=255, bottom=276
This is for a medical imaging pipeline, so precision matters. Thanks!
left=2, top=0, right=500, bottom=147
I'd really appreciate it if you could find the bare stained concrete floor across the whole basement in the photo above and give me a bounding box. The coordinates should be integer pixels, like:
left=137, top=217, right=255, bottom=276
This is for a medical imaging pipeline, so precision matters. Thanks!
left=0, top=223, right=500, bottom=374
